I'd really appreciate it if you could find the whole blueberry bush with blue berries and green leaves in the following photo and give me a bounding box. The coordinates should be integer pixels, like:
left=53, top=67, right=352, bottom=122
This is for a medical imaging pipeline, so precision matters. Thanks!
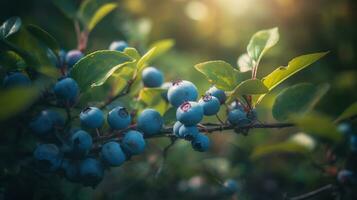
left=0, top=0, right=357, bottom=200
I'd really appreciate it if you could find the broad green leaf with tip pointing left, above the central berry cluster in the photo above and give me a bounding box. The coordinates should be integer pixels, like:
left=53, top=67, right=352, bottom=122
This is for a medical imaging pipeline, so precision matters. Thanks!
left=195, top=60, right=240, bottom=91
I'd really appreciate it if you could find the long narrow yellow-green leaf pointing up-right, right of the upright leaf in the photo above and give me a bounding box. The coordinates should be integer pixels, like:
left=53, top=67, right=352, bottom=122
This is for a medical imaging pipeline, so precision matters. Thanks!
left=256, top=52, right=328, bottom=104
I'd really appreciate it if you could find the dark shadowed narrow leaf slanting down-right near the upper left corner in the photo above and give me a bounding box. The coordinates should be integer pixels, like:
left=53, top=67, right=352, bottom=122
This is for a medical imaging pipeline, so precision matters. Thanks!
left=26, top=24, right=60, bottom=54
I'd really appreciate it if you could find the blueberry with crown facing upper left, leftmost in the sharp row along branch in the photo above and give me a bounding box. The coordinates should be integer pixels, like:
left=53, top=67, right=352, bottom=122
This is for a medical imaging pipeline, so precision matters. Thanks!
left=79, top=107, right=104, bottom=128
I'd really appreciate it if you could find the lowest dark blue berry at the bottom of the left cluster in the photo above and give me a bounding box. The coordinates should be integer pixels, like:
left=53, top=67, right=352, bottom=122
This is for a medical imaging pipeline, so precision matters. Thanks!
left=79, top=158, right=104, bottom=186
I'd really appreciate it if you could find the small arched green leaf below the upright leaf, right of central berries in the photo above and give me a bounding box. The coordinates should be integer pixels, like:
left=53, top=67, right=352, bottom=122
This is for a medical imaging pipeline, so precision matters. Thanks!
left=227, top=79, right=269, bottom=103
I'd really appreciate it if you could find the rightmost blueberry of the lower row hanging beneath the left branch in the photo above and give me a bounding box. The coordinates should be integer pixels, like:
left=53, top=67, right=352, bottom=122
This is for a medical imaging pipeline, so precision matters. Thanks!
left=122, top=130, right=145, bottom=155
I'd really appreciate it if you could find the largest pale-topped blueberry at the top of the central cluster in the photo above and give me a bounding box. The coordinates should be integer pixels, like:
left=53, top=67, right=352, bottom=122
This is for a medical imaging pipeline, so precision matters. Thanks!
left=167, top=81, right=198, bottom=107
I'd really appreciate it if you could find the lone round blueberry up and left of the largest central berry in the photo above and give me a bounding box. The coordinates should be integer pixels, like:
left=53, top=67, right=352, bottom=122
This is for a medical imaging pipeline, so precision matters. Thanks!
left=142, top=67, right=164, bottom=87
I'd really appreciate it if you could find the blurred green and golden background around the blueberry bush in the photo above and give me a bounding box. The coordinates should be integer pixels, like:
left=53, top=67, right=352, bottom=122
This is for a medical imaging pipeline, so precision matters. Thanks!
left=0, top=0, right=357, bottom=199
